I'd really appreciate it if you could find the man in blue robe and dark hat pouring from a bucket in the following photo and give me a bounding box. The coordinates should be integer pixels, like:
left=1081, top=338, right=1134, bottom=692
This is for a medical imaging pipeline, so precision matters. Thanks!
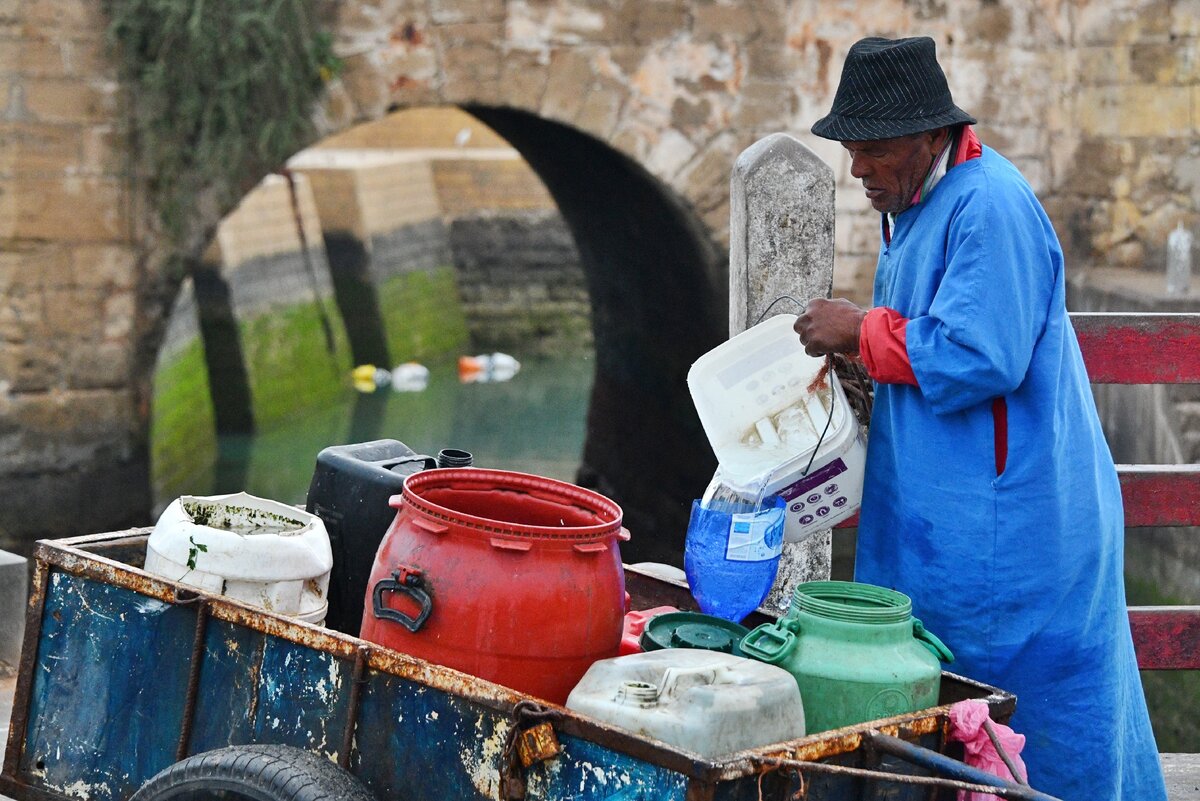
left=796, top=37, right=1166, bottom=801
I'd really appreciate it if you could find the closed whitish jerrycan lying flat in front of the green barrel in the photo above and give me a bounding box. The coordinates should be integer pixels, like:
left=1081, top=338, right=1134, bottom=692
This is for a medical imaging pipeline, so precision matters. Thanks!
left=566, top=648, right=804, bottom=758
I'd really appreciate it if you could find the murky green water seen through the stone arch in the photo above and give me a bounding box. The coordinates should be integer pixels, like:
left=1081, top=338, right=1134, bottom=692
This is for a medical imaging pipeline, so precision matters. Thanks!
left=155, top=354, right=593, bottom=513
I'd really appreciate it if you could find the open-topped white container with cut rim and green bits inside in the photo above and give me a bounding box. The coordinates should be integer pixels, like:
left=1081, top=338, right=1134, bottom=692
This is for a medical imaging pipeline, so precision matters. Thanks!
left=145, top=493, right=334, bottom=625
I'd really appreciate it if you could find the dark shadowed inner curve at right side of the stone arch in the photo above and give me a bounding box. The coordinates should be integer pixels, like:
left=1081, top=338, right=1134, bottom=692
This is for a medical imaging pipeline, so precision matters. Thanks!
left=466, top=106, right=728, bottom=564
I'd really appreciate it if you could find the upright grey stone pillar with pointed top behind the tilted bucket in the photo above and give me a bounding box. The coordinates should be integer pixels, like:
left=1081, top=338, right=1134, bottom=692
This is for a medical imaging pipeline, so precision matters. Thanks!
left=730, top=133, right=834, bottom=612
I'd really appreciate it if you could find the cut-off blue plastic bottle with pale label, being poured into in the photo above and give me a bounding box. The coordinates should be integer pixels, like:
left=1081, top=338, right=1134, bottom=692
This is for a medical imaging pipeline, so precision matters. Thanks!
left=683, top=495, right=785, bottom=622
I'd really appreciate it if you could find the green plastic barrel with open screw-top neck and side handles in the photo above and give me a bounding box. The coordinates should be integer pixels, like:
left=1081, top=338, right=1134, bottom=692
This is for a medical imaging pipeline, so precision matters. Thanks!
left=740, top=582, right=954, bottom=734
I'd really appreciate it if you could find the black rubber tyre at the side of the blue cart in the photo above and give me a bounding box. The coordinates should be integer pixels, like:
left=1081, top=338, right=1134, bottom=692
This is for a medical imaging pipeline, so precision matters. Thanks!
left=130, top=745, right=376, bottom=801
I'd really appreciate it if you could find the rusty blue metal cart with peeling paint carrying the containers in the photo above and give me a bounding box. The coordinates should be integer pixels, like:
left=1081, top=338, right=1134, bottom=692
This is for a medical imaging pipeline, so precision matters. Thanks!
left=0, top=529, right=1049, bottom=801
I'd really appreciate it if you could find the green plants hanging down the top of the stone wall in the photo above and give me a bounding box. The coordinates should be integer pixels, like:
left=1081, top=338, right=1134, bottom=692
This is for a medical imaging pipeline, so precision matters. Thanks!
left=104, top=0, right=341, bottom=239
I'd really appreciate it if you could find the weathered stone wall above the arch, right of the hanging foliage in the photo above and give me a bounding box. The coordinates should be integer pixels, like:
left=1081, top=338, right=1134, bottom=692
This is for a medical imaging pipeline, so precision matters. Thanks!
left=331, top=0, right=1200, bottom=297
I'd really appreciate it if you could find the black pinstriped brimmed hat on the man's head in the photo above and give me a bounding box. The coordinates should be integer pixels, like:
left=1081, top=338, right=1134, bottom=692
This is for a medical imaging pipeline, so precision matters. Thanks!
left=812, top=36, right=974, bottom=141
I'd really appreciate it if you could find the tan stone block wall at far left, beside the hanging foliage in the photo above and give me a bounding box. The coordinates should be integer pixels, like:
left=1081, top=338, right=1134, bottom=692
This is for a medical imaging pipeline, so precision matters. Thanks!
left=0, top=0, right=149, bottom=550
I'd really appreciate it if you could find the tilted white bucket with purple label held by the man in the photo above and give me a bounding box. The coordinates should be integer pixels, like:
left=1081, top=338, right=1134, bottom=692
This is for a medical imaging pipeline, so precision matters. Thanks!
left=688, top=314, right=866, bottom=542
